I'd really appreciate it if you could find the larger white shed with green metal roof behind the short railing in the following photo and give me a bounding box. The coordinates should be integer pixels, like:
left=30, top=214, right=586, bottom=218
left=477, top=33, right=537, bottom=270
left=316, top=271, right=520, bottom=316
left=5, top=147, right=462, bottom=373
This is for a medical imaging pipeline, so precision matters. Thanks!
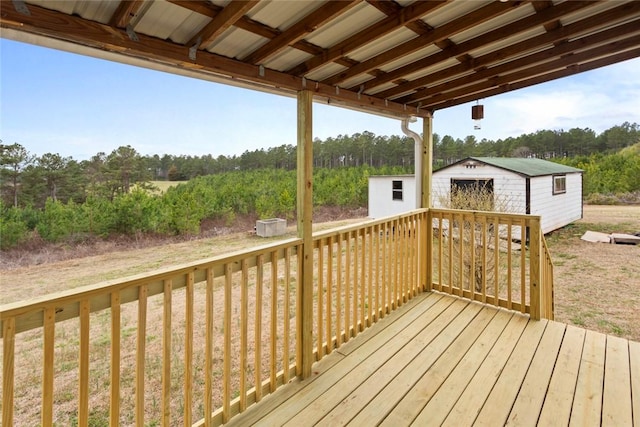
left=432, top=157, right=583, bottom=234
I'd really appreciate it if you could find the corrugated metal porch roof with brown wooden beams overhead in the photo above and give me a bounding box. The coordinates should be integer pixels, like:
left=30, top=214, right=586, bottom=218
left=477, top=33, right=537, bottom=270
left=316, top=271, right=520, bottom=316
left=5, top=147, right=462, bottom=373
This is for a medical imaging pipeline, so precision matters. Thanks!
left=0, top=0, right=640, bottom=117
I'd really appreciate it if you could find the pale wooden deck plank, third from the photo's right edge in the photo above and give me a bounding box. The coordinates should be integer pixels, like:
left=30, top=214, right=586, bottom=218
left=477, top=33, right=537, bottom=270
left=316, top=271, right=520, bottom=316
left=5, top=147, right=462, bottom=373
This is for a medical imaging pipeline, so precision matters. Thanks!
left=569, top=331, right=607, bottom=427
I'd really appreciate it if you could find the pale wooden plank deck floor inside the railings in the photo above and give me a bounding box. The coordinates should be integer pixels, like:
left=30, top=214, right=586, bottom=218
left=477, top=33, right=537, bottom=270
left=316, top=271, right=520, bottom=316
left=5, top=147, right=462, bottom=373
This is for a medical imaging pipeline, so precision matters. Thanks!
left=228, top=293, right=640, bottom=427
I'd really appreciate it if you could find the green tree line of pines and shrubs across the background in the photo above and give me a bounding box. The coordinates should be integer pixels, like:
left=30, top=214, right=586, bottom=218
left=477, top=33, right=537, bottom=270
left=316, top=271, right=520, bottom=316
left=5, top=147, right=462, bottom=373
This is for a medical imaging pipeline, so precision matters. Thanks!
left=0, top=123, right=640, bottom=249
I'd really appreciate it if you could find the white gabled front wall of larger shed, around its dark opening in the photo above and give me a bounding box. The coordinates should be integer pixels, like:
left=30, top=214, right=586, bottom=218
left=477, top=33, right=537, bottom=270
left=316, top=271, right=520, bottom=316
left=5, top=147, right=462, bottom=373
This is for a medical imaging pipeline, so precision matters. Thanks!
left=432, top=164, right=526, bottom=213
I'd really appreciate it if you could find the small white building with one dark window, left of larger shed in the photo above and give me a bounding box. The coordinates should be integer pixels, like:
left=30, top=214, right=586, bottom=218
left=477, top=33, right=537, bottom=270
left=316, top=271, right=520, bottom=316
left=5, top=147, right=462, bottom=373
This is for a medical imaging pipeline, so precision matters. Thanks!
left=369, top=175, right=416, bottom=218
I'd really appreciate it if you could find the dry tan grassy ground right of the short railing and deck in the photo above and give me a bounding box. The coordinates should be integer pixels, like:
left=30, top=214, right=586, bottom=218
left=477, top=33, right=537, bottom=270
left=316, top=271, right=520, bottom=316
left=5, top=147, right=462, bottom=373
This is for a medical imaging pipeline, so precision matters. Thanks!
left=547, top=205, right=640, bottom=341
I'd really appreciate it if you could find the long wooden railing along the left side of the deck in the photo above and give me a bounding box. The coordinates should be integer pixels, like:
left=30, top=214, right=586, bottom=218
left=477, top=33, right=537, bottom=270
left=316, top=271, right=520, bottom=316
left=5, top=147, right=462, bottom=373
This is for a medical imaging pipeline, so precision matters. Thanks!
left=0, top=210, right=427, bottom=426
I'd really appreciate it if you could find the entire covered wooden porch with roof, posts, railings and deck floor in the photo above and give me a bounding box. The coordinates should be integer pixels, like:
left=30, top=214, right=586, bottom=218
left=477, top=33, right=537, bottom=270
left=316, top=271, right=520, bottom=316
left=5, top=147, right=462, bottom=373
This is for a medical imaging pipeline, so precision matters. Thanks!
left=0, top=0, right=640, bottom=426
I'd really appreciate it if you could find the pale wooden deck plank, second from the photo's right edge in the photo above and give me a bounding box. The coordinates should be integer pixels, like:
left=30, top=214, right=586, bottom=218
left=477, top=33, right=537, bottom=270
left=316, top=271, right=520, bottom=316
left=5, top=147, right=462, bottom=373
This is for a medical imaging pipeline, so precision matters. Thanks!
left=602, top=335, right=633, bottom=426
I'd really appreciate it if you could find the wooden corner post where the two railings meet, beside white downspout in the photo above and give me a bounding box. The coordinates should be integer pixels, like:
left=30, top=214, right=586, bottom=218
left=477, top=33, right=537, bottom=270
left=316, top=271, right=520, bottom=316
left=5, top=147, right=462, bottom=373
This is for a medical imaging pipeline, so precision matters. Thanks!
left=416, top=113, right=433, bottom=291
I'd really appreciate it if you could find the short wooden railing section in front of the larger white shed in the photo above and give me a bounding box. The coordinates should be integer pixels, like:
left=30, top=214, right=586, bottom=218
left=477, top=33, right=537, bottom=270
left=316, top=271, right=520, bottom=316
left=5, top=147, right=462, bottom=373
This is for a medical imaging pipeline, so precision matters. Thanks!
left=427, top=209, right=553, bottom=319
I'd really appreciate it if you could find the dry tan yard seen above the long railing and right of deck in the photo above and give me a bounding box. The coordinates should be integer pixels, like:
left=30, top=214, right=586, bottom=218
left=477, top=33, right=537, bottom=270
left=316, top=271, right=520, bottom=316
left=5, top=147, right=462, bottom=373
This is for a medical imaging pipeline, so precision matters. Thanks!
left=0, top=206, right=640, bottom=341
